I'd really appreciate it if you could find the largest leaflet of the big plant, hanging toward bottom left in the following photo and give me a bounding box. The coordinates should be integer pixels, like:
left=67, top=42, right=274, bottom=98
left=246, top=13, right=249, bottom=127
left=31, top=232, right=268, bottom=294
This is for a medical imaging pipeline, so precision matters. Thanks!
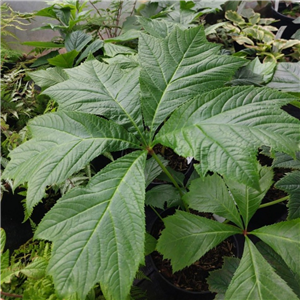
left=35, top=151, right=146, bottom=300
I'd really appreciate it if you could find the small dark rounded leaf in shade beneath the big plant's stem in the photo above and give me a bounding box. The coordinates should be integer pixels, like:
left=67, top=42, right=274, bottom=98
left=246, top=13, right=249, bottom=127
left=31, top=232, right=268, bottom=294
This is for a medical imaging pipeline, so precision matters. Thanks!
left=145, top=184, right=182, bottom=209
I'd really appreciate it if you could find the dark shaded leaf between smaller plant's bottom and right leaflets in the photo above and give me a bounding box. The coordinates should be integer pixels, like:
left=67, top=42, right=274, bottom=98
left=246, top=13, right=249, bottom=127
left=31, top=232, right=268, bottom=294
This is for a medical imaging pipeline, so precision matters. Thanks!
left=255, top=242, right=300, bottom=297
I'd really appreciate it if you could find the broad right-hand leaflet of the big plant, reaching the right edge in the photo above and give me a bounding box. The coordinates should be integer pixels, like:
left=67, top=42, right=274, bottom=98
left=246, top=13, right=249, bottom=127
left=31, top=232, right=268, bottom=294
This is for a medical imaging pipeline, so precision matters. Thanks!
left=154, top=87, right=300, bottom=189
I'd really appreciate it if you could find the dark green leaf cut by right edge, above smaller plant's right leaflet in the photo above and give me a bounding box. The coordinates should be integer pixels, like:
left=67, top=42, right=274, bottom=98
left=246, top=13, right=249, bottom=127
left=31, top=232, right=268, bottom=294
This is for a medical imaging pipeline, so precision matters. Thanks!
left=275, top=171, right=300, bottom=220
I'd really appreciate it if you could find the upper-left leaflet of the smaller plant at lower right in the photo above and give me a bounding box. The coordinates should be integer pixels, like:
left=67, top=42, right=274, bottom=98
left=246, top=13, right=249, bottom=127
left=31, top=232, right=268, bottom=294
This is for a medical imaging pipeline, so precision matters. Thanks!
left=183, top=174, right=243, bottom=228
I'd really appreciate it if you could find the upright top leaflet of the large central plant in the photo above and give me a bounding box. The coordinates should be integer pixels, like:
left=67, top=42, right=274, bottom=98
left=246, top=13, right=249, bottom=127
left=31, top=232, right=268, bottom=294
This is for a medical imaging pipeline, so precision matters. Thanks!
left=139, top=27, right=244, bottom=138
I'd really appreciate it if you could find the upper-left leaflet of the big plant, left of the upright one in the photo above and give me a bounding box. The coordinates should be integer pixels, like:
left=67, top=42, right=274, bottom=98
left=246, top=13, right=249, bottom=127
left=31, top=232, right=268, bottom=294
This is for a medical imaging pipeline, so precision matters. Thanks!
left=44, top=60, right=142, bottom=132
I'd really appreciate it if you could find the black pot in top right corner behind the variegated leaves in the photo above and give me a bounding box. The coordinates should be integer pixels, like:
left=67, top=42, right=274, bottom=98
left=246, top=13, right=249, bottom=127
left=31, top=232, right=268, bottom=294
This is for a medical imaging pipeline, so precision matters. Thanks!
left=271, top=3, right=300, bottom=40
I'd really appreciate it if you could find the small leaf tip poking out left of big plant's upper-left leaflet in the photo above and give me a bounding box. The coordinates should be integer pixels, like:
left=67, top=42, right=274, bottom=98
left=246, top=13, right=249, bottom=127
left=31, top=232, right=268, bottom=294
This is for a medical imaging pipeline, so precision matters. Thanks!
left=29, top=67, right=68, bottom=88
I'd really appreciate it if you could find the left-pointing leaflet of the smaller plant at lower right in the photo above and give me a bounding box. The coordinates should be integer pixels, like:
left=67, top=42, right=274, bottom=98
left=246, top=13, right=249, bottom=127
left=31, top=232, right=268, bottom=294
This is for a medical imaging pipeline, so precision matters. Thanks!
left=157, top=211, right=241, bottom=272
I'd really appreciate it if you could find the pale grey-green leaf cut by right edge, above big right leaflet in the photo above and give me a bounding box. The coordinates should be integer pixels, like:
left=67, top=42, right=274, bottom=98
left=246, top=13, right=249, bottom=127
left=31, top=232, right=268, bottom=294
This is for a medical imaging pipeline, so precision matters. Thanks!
left=268, top=62, right=300, bottom=92
